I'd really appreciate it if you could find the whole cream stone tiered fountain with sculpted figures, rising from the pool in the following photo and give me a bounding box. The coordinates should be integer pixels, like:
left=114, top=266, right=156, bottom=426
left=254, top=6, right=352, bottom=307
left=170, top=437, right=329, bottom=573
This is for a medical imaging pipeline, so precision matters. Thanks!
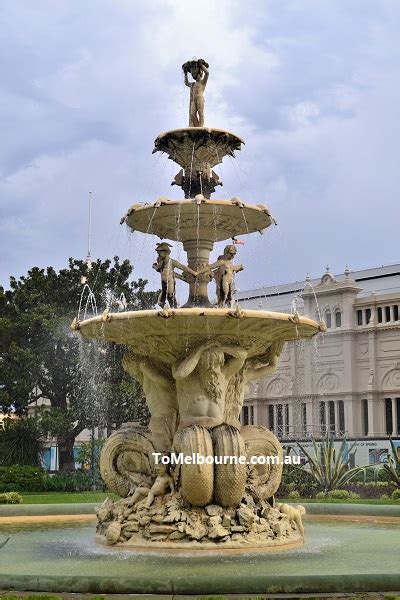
left=72, top=59, right=323, bottom=551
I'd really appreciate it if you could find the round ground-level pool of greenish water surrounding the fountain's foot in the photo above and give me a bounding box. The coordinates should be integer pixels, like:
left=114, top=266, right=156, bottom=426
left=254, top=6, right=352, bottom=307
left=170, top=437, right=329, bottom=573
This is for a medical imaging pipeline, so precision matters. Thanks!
left=0, top=506, right=400, bottom=596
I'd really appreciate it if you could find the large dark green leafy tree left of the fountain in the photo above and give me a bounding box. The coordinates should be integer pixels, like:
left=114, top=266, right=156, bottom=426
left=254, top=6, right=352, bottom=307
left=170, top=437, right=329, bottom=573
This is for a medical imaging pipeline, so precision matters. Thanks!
left=0, top=257, right=157, bottom=470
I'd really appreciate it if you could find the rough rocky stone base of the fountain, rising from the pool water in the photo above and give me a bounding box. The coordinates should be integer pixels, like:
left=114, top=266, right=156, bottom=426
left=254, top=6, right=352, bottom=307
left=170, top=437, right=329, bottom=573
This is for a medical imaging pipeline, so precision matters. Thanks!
left=96, top=490, right=303, bottom=552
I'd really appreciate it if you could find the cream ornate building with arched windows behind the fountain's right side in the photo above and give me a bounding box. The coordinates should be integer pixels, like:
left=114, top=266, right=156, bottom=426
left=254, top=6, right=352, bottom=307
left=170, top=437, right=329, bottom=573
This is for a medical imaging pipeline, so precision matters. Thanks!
left=237, top=264, right=400, bottom=464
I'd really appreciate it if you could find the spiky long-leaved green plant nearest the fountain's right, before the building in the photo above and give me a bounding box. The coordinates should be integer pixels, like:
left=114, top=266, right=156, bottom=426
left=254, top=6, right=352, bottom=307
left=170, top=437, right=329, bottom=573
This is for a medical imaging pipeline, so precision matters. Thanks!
left=297, top=436, right=364, bottom=492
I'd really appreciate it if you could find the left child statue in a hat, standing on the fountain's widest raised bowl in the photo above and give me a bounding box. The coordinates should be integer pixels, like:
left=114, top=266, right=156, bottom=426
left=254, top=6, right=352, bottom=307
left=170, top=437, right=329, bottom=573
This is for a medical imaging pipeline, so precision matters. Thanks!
left=153, top=242, right=196, bottom=308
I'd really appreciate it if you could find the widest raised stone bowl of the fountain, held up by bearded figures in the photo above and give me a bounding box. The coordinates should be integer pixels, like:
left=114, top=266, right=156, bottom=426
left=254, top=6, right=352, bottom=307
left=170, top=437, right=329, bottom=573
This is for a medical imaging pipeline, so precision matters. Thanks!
left=75, top=308, right=323, bottom=365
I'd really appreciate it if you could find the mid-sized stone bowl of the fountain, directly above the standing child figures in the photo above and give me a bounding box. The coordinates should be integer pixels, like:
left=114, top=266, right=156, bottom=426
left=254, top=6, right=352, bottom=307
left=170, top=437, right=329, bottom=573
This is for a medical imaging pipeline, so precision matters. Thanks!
left=124, top=196, right=274, bottom=242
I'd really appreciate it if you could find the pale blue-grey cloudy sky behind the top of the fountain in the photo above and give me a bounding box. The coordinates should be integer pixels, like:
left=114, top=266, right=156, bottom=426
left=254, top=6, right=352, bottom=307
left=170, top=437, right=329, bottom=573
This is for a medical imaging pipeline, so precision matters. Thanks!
left=0, top=0, right=400, bottom=290
